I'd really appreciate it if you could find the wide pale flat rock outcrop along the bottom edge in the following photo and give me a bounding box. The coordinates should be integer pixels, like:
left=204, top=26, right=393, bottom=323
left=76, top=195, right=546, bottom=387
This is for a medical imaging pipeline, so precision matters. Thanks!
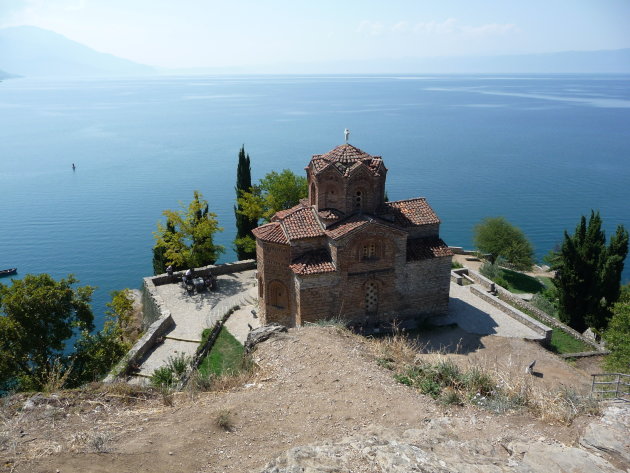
left=261, top=423, right=621, bottom=473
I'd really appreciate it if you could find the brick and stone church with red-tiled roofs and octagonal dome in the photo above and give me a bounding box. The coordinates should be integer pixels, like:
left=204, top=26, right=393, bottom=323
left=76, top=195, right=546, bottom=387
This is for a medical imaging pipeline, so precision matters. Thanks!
left=253, top=140, right=452, bottom=331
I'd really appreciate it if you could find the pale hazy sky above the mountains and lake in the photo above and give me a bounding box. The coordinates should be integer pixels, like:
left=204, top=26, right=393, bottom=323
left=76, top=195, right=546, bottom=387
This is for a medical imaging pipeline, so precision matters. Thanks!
left=0, top=0, right=630, bottom=67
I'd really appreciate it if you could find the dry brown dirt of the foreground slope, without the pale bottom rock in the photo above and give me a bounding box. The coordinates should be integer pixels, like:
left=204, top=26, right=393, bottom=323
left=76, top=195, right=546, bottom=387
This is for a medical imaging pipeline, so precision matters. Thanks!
left=0, top=327, right=604, bottom=473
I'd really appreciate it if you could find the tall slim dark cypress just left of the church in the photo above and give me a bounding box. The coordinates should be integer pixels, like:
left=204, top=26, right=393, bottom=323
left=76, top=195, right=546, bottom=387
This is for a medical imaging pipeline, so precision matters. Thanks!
left=234, top=146, right=258, bottom=260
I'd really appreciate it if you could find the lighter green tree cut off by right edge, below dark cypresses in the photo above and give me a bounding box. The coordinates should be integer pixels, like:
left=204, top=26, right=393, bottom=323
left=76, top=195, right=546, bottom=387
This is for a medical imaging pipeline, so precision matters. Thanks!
left=604, top=300, right=630, bottom=373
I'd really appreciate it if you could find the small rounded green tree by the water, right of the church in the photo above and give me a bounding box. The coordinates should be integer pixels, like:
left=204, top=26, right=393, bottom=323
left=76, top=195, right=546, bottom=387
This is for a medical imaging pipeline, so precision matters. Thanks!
left=473, top=217, right=534, bottom=270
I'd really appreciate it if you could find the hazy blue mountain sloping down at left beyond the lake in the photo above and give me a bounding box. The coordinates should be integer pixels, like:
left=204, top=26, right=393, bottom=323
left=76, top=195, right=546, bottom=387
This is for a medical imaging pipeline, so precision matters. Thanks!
left=0, top=26, right=154, bottom=77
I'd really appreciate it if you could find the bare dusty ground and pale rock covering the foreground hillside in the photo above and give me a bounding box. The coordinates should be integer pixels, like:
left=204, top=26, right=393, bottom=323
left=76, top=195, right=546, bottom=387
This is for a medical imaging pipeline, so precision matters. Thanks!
left=0, top=327, right=630, bottom=473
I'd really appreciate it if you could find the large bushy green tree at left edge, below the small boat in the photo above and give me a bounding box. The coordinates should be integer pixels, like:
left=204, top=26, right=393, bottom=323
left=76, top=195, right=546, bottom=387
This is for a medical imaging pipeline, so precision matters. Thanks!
left=0, top=274, right=94, bottom=390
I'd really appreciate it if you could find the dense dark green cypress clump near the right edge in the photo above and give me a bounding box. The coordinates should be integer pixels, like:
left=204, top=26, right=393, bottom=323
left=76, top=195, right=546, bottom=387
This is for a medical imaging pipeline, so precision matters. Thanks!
left=549, top=211, right=628, bottom=332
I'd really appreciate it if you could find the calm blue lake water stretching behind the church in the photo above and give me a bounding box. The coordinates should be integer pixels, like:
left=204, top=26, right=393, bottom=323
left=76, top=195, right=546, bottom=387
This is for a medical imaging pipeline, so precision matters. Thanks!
left=0, top=75, right=630, bottom=328
